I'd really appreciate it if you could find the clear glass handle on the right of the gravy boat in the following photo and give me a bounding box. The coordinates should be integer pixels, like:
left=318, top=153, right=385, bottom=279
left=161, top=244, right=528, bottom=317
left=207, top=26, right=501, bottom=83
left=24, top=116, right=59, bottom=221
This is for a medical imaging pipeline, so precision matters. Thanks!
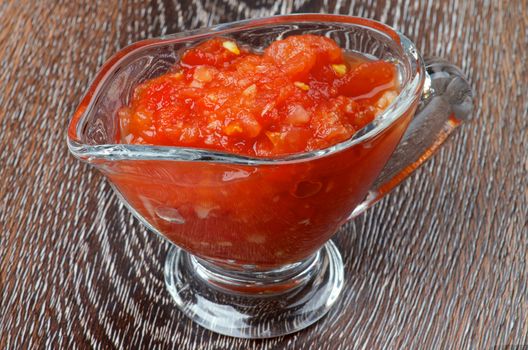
left=349, top=57, right=473, bottom=219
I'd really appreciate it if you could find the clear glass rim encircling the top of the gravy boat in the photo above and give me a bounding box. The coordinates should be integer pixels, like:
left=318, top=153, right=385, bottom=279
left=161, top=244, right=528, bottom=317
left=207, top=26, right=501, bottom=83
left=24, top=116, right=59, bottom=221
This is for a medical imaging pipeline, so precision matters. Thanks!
left=67, top=13, right=425, bottom=165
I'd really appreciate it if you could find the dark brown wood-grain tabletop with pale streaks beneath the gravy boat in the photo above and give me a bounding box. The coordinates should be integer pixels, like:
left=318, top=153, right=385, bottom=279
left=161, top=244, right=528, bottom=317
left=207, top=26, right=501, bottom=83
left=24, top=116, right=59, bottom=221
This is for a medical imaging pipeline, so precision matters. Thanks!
left=0, top=0, right=528, bottom=349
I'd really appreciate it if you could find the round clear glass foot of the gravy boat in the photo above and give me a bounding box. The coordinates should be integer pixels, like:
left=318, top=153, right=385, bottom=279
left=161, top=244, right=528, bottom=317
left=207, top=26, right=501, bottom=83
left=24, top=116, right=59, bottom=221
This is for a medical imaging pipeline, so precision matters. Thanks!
left=165, top=241, right=343, bottom=339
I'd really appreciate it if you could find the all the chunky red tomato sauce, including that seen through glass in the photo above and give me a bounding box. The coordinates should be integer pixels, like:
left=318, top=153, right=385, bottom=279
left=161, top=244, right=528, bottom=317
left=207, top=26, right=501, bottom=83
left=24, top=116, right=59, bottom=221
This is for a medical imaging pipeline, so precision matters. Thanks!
left=108, top=35, right=416, bottom=269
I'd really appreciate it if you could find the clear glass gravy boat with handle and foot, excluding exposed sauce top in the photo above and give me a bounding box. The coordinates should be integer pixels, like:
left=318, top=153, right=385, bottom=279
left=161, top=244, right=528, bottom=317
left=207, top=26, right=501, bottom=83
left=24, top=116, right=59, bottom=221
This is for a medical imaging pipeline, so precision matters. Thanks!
left=68, top=14, right=472, bottom=338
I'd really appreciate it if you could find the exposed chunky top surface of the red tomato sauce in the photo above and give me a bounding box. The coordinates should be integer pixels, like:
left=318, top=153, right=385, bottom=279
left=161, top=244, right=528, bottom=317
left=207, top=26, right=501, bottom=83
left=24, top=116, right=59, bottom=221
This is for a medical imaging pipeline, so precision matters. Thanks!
left=118, top=34, right=399, bottom=157
